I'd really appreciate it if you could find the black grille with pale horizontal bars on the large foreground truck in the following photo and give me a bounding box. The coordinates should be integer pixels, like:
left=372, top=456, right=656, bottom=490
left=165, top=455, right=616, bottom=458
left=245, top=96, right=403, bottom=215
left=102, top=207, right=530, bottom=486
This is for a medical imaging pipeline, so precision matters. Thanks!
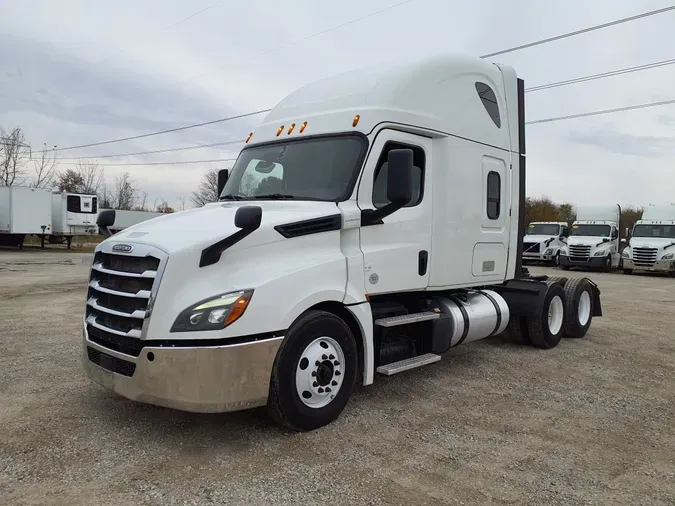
left=86, top=244, right=166, bottom=356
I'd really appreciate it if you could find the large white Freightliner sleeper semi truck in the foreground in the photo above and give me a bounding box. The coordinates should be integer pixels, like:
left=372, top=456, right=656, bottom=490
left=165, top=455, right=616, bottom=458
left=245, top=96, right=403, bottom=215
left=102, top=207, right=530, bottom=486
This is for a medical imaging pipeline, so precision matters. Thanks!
left=82, top=55, right=602, bottom=430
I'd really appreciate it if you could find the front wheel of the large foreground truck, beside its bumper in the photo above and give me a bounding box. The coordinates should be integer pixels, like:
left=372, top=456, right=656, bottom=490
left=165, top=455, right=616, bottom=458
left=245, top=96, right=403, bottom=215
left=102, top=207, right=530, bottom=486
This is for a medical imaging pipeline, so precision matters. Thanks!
left=267, top=310, right=358, bottom=432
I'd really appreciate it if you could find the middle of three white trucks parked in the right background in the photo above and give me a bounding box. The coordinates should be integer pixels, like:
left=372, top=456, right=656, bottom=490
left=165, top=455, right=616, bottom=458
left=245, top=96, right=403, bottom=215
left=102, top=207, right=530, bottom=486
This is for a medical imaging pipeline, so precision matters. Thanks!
left=560, top=204, right=621, bottom=272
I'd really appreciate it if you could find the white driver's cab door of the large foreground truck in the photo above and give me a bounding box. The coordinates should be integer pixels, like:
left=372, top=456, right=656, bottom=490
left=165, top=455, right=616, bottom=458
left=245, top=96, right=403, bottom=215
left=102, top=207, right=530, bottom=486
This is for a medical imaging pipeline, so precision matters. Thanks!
left=357, top=129, right=432, bottom=295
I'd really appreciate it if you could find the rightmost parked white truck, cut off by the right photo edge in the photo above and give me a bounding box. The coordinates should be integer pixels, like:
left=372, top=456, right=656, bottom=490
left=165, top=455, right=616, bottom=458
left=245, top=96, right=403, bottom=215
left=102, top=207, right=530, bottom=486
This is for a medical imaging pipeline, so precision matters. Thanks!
left=621, top=205, right=675, bottom=277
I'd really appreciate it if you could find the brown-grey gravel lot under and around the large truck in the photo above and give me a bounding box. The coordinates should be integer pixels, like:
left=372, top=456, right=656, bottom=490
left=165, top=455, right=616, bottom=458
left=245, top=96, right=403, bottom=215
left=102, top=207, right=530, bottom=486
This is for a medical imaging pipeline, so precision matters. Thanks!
left=0, top=251, right=675, bottom=506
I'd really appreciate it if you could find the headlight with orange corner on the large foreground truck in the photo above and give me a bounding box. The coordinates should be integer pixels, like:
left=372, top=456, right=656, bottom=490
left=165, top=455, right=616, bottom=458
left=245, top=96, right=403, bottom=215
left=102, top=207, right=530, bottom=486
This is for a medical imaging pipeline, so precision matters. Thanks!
left=171, top=290, right=253, bottom=332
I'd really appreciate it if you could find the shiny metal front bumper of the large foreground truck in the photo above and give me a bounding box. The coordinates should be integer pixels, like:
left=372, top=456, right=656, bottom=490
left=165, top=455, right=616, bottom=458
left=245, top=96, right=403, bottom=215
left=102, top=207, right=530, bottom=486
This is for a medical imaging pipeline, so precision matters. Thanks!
left=82, top=327, right=283, bottom=413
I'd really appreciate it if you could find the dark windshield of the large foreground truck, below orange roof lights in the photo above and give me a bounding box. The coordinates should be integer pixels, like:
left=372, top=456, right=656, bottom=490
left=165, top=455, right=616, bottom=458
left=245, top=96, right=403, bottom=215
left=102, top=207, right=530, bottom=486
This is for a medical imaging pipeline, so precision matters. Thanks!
left=220, top=135, right=368, bottom=202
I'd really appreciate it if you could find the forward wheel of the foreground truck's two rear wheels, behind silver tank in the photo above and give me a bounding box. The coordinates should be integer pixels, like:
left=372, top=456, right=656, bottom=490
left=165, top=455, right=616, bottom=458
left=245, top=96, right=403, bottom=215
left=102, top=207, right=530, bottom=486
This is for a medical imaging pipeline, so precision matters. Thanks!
left=527, top=282, right=565, bottom=349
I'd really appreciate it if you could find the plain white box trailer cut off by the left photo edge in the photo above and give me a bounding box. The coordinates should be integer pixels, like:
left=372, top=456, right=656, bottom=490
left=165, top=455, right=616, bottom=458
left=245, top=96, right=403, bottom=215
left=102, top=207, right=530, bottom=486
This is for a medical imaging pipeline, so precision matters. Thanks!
left=0, top=186, right=52, bottom=248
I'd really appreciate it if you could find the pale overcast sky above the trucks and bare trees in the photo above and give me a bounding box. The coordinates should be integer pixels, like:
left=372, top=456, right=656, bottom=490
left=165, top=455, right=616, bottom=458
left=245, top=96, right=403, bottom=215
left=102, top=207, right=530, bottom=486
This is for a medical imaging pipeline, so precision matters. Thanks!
left=0, top=0, right=675, bottom=210
